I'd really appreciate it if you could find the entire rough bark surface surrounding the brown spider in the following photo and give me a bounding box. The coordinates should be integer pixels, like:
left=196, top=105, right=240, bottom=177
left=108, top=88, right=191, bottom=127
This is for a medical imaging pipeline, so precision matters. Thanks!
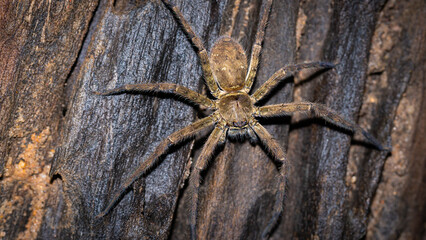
left=0, top=0, right=426, bottom=240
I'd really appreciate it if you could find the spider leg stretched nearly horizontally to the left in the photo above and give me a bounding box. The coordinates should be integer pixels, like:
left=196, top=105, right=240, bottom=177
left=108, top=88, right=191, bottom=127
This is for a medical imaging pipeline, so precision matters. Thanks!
left=94, top=83, right=216, bottom=108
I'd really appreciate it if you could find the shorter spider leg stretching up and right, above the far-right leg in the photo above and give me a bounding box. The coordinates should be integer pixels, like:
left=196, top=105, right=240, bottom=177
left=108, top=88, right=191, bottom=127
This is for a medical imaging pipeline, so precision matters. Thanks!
left=252, top=62, right=334, bottom=102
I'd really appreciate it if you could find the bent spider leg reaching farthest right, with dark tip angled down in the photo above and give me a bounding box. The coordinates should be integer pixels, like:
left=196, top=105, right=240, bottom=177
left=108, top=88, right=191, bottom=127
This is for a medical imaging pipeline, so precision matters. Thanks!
left=255, top=102, right=388, bottom=151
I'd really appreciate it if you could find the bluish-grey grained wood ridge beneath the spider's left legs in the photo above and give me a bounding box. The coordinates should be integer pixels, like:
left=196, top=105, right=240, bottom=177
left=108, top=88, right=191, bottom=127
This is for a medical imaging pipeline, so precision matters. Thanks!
left=50, top=1, right=220, bottom=239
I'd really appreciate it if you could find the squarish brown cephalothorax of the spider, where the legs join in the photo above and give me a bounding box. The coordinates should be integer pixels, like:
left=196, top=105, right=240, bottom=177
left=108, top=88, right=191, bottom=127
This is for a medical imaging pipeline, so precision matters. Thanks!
left=217, top=92, right=254, bottom=129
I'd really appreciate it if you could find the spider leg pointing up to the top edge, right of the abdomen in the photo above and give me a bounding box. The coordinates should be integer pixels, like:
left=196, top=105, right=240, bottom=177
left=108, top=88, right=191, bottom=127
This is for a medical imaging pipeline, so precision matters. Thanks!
left=244, top=0, right=273, bottom=93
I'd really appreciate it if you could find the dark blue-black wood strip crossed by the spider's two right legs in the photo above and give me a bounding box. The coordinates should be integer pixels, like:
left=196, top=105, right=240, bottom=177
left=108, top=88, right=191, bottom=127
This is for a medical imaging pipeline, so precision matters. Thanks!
left=279, top=1, right=387, bottom=239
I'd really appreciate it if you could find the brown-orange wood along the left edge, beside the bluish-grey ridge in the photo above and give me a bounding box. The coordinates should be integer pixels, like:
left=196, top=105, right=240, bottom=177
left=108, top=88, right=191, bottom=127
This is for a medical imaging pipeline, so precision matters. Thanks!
left=0, top=1, right=97, bottom=239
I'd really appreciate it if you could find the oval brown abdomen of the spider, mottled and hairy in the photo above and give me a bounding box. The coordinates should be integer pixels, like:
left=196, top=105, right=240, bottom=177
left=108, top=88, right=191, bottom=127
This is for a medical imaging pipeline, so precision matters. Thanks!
left=210, top=37, right=247, bottom=92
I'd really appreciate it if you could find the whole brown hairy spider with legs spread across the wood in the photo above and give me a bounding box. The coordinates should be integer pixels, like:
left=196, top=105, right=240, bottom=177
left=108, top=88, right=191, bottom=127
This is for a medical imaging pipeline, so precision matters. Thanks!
left=95, top=0, right=383, bottom=239
